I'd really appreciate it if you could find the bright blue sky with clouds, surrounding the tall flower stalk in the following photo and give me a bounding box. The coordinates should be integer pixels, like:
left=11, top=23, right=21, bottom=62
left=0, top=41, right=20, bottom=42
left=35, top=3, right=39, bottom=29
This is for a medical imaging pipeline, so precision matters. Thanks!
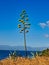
left=0, top=0, right=49, bottom=47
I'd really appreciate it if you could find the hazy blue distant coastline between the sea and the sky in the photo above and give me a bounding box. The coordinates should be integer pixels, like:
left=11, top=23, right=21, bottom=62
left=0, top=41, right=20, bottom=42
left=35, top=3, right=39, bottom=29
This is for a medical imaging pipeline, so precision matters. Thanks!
left=0, top=45, right=49, bottom=51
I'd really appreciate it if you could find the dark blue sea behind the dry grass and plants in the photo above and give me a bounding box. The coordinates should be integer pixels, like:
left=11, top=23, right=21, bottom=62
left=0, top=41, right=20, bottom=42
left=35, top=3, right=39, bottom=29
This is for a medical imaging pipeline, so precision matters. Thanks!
left=0, top=50, right=41, bottom=60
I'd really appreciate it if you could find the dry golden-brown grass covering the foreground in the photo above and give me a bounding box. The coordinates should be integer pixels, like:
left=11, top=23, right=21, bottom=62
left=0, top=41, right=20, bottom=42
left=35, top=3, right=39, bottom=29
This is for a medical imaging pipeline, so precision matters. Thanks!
left=0, top=56, right=49, bottom=65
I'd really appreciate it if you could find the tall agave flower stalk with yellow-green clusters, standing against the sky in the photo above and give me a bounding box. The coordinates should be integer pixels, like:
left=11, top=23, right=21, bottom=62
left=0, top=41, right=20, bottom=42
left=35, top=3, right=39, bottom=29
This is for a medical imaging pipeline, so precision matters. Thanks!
left=18, top=10, right=30, bottom=57
